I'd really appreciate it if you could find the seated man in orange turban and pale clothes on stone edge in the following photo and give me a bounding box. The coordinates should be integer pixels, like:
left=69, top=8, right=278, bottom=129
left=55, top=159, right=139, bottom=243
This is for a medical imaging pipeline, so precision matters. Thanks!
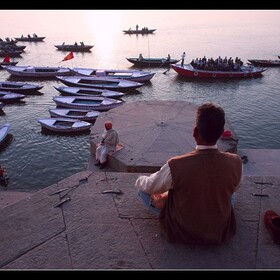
left=95, top=121, right=119, bottom=169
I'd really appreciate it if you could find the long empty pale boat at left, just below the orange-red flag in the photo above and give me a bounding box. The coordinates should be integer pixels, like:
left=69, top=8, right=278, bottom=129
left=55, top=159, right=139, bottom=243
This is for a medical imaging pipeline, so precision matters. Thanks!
left=4, top=66, right=72, bottom=78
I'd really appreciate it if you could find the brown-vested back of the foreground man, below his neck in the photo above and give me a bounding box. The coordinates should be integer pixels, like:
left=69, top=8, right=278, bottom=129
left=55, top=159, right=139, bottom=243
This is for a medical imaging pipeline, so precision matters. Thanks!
left=160, top=149, right=242, bottom=244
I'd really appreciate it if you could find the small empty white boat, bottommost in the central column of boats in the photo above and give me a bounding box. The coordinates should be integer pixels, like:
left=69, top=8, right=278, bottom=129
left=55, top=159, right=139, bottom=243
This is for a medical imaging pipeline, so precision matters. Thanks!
left=37, top=118, right=92, bottom=133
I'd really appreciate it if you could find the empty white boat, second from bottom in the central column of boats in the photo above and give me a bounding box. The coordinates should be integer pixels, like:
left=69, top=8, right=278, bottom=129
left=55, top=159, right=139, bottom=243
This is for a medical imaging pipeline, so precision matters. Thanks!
left=49, top=108, right=100, bottom=122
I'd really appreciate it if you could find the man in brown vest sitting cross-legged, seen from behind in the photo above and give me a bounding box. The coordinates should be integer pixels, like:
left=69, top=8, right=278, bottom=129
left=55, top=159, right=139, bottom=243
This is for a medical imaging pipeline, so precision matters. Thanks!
left=135, top=103, right=242, bottom=245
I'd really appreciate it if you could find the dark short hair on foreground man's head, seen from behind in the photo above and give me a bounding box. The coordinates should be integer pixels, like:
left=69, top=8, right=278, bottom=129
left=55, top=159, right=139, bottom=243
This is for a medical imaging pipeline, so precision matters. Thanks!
left=196, top=103, right=225, bottom=143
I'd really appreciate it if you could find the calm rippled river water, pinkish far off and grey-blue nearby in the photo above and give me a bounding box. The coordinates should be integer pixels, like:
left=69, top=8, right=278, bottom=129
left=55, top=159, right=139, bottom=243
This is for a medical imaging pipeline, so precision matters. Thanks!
left=0, top=10, right=280, bottom=191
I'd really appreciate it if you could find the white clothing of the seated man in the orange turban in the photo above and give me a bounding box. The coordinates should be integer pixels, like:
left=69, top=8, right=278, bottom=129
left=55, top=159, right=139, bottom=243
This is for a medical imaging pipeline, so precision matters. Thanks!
left=95, top=128, right=119, bottom=163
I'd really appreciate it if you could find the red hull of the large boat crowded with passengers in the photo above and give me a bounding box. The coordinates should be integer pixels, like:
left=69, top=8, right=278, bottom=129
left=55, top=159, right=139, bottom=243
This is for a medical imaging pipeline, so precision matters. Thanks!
left=171, top=64, right=266, bottom=79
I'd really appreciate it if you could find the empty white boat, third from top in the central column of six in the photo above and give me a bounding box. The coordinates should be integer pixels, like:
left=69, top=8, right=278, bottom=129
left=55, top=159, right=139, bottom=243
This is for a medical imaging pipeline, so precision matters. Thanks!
left=54, top=86, right=125, bottom=98
